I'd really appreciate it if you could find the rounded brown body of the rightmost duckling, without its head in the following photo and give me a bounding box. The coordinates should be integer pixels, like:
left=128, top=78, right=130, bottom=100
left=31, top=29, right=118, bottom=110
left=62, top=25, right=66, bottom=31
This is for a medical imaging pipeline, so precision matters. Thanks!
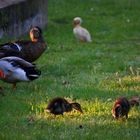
left=112, top=97, right=130, bottom=119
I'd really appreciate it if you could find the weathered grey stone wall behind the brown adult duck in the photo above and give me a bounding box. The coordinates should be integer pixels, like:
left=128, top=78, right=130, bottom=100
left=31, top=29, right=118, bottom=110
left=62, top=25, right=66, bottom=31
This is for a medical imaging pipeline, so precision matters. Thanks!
left=0, top=0, right=47, bottom=38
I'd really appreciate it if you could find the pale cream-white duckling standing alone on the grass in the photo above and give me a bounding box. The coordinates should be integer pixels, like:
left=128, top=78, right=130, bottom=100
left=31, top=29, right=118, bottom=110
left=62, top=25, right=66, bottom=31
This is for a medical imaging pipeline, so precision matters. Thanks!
left=73, top=17, right=92, bottom=42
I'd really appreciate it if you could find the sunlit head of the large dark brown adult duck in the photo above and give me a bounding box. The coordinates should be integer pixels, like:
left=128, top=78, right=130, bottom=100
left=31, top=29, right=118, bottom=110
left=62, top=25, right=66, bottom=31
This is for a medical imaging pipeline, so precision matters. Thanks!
left=30, top=26, right=42, bottom=42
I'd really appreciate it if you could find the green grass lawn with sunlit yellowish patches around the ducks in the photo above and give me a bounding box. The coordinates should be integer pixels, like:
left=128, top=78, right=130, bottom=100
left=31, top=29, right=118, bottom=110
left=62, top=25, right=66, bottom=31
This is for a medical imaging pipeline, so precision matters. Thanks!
left=0, top=0, right=140, bottom=140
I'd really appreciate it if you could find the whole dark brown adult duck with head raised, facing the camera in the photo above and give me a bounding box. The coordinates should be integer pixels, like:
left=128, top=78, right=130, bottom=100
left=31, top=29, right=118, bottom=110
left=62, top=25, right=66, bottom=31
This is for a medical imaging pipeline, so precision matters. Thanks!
left=0, top=26, right=47, bottom=62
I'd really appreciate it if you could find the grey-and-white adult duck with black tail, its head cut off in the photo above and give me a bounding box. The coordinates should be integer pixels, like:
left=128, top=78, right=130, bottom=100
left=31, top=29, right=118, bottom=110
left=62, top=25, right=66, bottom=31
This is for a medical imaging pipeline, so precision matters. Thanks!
left=0, top=56, right=41, bottom=89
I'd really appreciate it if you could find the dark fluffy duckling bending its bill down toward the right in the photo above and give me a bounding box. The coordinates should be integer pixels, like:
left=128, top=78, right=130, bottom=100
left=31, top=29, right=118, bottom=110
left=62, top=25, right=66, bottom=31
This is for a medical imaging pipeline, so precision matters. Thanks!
left=45, top=97, right=83, bottom=115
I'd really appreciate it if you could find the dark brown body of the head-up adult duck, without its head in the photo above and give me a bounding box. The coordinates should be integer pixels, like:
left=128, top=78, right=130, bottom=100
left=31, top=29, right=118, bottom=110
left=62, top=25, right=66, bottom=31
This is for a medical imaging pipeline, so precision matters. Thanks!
left=0, top=39, right=46, bottom=62
